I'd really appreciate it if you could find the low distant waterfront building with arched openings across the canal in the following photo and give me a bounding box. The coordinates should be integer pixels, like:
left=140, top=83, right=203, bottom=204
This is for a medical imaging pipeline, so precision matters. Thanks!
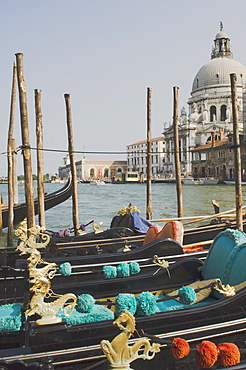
left=58, top=156, right=127, bottom=180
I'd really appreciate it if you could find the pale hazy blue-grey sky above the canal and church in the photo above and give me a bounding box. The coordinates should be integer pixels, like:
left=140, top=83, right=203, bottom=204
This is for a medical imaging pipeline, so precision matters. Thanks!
left=0, top=0, right=246, bottom=176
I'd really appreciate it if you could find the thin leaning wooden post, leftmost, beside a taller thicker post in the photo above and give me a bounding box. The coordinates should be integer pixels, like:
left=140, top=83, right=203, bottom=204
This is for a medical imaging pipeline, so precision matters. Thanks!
left=7, top=63, right=17, bottom=245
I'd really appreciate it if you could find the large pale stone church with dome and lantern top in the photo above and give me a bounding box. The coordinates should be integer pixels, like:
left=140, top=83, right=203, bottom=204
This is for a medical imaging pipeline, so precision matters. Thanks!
left=163, top=23, right=246, bottom=174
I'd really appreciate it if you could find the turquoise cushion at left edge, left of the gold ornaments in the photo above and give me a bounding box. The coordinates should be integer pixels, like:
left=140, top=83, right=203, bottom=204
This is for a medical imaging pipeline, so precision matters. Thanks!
left=0, top=303, right=21, bottom=332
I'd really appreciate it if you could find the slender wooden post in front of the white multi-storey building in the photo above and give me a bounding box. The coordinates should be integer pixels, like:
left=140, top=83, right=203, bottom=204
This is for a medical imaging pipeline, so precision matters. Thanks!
left=146, top=87, right=152, bottom=220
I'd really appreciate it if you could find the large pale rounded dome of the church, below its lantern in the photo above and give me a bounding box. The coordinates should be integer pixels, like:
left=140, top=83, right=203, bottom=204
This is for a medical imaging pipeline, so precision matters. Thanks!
left=192, top=57, right=246, bottom=92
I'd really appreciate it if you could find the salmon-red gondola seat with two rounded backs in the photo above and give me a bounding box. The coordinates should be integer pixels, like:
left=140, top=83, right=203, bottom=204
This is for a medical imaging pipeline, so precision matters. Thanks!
left=143, top=221, right=184, bottom=245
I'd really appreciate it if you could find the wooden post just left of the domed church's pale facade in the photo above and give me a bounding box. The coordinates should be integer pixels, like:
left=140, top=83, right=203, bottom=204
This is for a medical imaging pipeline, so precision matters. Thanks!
left=173, top=86, right=183, bottom=217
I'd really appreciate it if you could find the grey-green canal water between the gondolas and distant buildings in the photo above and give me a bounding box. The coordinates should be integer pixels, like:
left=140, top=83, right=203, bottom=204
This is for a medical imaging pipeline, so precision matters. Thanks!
left=0, top=183, right=246, bottom=244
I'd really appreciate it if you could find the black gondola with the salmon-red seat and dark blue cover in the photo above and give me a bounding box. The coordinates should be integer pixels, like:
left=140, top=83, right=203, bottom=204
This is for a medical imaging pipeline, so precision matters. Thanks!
left=5, top=211, right=246, bottom=267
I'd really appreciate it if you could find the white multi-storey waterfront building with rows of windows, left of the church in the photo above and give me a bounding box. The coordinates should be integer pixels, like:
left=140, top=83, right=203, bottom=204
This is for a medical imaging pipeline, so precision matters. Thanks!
left=127, top=137, right=165, bottom=175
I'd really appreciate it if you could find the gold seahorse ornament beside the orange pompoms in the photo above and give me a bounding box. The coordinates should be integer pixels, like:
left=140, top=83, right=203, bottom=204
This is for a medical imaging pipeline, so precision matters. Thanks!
left=100, top=310, right=160, bottom=370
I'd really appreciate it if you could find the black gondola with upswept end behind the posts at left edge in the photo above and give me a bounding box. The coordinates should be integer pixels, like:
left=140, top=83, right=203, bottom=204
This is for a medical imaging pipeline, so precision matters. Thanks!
left=2, top=176, right=72, bottom=228
